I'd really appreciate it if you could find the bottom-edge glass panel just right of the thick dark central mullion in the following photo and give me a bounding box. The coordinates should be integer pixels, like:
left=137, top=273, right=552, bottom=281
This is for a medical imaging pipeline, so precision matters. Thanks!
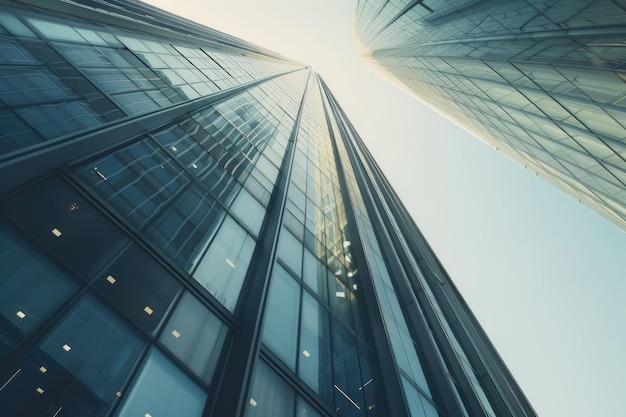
left=245, top=361, right=294, bottom=417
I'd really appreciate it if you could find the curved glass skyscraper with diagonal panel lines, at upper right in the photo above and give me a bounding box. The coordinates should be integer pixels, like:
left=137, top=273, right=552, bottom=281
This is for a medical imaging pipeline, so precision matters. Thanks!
left=355, top=0, right=626, bottom=230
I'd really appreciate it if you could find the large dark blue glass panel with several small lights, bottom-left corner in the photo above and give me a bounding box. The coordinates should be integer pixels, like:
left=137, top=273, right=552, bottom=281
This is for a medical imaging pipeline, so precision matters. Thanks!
left=0, top=296, right=143, bottom=417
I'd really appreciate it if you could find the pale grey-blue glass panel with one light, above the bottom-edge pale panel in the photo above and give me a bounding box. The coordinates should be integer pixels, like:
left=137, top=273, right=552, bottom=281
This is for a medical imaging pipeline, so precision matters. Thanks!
left=159, top=292, right=228, bottom=383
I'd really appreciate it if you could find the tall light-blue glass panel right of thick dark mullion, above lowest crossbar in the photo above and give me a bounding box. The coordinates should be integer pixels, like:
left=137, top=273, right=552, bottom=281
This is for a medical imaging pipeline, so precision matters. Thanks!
left=263, top=264, right=300, bottom=369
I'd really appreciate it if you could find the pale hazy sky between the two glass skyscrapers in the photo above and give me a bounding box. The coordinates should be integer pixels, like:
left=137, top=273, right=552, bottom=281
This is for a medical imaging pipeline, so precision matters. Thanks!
left=143, top=0, right=626, bottom=417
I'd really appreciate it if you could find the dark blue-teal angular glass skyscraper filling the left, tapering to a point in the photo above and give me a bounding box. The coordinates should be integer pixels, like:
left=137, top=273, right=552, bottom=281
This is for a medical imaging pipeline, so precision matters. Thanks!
left=0, top=0, right=534, bottom=417
